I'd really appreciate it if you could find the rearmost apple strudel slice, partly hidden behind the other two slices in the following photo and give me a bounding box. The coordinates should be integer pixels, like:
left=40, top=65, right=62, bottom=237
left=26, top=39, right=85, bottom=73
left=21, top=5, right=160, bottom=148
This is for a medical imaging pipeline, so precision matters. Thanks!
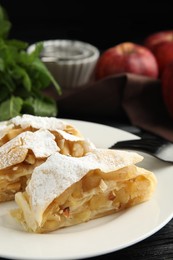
left=0, top=114, right=94, bottom=157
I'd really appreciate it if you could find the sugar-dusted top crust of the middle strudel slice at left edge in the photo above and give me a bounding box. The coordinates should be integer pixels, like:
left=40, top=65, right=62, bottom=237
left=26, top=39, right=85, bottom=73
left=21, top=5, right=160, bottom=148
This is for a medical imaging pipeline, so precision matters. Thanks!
left=0, top=130, right=60, bottom=169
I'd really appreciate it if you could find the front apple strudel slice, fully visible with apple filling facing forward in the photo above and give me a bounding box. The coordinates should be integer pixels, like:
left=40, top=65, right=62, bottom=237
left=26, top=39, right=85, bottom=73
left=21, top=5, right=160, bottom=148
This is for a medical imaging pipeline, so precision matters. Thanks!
left=11, top=149, right=156, bottom=233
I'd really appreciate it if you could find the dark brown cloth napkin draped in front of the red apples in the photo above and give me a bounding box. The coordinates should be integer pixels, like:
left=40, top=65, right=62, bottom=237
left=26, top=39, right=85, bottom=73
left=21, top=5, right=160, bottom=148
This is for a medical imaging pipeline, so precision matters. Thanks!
left=48, top=74, right=173, bottom=141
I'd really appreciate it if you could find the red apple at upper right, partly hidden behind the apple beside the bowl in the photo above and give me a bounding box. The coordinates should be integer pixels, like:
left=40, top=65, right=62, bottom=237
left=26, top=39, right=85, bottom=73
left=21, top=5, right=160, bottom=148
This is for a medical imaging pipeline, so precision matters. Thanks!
left=144, top=30, right=173, bottom=77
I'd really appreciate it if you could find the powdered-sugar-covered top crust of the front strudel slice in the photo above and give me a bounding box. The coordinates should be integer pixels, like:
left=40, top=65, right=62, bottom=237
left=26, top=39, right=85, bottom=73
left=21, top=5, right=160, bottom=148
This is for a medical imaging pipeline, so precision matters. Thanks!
left=26, top=149, right=143, bottom=223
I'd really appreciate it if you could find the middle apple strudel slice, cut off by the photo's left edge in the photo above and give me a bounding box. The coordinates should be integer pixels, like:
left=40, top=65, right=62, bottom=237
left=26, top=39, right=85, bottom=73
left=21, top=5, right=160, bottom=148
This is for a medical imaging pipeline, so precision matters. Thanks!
left=0, top=130, right=60, bottom=202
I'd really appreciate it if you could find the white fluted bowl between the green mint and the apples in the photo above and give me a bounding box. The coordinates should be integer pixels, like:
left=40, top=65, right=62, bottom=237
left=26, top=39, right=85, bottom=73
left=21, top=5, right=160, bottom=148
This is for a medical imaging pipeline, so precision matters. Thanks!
left=28, top=40, right=100, bottom=88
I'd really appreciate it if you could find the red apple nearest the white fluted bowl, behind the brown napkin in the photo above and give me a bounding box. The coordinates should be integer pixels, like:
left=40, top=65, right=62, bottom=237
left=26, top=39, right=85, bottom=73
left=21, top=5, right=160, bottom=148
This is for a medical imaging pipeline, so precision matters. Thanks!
left=95, top=42, right=158, bottom=79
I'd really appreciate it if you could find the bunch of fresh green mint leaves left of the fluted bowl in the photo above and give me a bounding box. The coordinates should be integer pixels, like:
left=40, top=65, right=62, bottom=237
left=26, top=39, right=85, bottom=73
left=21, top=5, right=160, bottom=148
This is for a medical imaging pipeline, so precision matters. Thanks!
left=0, top=5, right=61, bottom=120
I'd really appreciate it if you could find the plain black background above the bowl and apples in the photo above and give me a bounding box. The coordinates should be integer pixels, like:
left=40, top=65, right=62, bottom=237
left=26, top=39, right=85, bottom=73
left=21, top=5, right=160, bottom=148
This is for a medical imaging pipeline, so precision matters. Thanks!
left=0, top=0, right=173, bottom=50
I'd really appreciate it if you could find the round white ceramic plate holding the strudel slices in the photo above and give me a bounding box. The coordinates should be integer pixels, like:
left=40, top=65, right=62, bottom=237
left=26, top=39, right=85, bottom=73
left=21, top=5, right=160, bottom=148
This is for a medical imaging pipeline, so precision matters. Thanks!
left=0, top=120, right=173, bottom=260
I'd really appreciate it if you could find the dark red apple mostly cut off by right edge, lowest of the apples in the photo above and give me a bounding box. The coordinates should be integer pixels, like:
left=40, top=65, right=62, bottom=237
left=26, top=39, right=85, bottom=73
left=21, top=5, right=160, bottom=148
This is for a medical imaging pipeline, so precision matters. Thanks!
left=161, top=62, right=173, bottom=118
